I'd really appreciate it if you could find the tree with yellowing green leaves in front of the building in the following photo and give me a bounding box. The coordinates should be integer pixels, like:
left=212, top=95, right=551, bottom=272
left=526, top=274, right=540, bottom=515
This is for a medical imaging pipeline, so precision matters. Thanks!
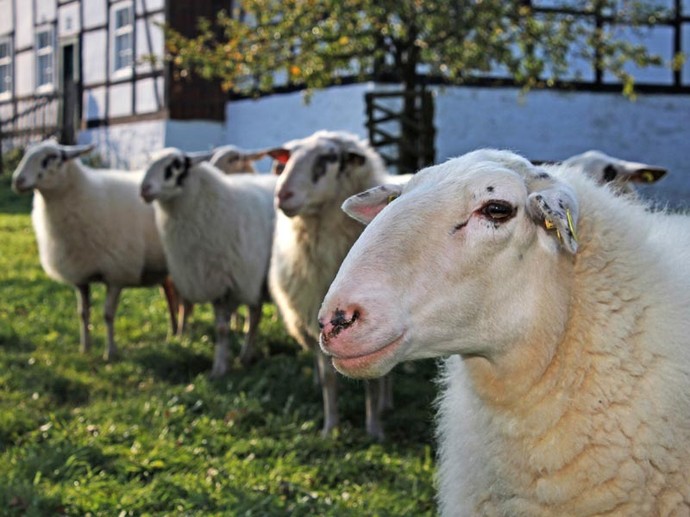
left=166, top=0, right=668, bottom=170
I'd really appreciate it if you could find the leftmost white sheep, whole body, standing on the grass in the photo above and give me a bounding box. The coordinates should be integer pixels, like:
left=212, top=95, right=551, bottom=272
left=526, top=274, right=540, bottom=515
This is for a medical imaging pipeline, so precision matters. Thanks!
left=12, top=140, right=175, bottom=360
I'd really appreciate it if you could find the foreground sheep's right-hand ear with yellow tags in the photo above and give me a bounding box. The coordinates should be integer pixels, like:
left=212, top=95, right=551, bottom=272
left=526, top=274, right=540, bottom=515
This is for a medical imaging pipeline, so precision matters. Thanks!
left=527, top=184, right=578, bottom=255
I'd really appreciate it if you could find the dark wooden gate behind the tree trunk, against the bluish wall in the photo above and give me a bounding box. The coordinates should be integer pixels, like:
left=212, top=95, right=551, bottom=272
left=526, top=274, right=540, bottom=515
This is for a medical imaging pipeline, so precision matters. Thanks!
left=365, top=89, right=436, bottom=174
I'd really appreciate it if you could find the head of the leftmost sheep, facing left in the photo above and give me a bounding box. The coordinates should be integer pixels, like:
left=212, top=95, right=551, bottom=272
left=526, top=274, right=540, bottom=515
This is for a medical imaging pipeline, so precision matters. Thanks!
left=12, top=139, right=94, bottom=193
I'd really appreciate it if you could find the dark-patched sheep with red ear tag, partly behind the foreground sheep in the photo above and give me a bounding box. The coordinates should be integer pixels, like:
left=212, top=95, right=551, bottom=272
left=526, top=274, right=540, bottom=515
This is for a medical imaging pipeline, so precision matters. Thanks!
left=269, top=131, right=388, bottom=439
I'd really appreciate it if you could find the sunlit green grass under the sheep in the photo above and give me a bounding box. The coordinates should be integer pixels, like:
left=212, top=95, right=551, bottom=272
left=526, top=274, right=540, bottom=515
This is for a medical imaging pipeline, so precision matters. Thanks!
left=0, top=170, right=435, bottom=516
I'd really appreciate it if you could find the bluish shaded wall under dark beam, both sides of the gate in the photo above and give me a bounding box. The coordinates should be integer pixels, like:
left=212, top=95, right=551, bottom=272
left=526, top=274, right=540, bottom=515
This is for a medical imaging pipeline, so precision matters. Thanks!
left=227, top=84, right=690, bottom=206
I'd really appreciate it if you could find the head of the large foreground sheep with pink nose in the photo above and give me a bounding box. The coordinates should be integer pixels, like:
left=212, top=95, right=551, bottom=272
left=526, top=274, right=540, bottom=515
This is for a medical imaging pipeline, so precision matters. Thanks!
left=319, top=150, right=578, bottom=377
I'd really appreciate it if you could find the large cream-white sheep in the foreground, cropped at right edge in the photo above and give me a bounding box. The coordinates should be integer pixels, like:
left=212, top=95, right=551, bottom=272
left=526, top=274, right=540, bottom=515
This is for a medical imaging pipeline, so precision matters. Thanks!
left=320, top=150, right=690, bottom=516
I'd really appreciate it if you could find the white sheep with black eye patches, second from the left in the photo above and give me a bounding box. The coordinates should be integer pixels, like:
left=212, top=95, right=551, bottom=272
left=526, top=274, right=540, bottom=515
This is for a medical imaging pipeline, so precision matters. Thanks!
left=141, top=148, right=276, bottom=376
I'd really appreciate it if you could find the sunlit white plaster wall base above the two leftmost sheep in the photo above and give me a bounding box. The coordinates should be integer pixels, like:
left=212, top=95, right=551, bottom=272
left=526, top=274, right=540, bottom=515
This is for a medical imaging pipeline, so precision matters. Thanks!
left=79, top=120, right=166, bottom=169
